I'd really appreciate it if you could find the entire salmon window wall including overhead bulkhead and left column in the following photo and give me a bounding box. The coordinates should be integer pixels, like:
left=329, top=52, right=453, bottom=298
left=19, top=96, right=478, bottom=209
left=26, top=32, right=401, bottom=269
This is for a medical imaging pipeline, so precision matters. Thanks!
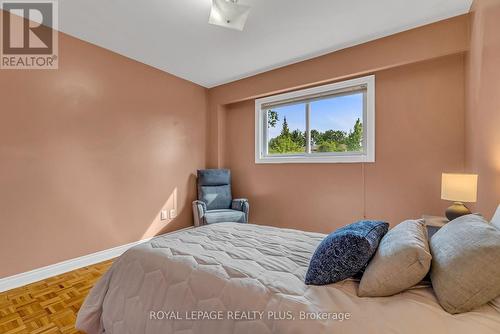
left=207, top=15, right=469, bottom=232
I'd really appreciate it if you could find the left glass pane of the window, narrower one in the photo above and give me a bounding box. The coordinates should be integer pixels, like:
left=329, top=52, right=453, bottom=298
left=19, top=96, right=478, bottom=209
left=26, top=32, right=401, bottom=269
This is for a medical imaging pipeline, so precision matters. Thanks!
left=267, top=103, right=306, bottom=155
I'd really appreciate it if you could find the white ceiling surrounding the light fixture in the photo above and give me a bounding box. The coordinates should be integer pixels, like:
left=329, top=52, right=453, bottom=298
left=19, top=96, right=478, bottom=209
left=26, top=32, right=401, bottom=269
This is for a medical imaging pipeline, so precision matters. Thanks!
left=55, top=0, right=472, bottom=87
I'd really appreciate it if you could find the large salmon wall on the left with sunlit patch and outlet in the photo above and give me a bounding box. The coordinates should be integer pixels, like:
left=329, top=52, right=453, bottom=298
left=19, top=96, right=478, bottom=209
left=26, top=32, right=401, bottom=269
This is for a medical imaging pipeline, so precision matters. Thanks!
left=0, top=24, right=206, bottom=277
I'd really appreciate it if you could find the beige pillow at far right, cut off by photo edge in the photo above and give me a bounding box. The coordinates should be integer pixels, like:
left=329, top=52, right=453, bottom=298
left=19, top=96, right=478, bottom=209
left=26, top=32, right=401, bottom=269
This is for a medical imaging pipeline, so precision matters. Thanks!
left=430, top=215, right=500, bottom=314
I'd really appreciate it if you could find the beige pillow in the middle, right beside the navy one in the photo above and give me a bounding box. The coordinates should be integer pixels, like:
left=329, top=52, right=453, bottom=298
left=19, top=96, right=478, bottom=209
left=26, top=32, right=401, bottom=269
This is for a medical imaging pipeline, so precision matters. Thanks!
left=358, top=220, right=432, bottom=297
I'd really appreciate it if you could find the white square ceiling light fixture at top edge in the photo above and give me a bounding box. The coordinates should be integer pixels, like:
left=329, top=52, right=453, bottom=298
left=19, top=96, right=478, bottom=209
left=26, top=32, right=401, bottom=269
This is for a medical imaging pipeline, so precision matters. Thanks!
left=208, top=0, right=250, bottom=31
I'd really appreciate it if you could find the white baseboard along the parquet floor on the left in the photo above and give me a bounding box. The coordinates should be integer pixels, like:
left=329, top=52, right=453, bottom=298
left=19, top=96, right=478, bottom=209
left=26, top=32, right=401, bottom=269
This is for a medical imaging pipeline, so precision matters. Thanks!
left=0, top=227, right=192, bottom=292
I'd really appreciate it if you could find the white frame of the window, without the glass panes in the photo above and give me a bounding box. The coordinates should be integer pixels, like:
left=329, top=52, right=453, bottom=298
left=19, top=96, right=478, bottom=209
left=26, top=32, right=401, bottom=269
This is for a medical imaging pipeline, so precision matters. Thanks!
left=255, top=75, right=375, bottom=164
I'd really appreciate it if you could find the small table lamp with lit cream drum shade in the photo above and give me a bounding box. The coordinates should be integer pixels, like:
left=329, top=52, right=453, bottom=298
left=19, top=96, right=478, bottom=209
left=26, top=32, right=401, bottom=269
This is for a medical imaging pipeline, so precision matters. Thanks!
left=441, top=173, right=477, bottom=221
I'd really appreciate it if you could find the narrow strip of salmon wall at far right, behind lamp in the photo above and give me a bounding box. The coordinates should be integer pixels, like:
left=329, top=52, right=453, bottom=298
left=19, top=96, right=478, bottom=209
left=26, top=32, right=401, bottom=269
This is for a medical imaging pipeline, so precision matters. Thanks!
left=466, top=0, right=500, bottom=217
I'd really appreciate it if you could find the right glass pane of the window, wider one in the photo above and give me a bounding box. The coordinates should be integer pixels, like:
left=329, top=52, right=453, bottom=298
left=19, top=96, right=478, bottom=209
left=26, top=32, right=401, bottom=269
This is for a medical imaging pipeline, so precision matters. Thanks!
left=310, top=92, right=364, bottom=153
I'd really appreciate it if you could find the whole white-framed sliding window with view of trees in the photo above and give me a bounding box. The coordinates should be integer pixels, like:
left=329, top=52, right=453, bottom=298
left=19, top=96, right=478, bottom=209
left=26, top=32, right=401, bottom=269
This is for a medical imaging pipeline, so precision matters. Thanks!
left=255, top=76, right=375, bottom=163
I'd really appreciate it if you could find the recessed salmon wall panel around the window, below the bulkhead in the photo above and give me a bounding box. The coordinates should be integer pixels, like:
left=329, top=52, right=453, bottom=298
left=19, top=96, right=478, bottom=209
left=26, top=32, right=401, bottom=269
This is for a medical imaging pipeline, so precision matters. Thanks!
left=225, top=54, right=464, bottom=232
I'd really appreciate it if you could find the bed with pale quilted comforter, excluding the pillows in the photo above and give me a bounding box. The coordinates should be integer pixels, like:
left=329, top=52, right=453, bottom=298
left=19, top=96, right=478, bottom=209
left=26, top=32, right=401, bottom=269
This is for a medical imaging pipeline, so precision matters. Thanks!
left=76, top=223, right=500, bottom=334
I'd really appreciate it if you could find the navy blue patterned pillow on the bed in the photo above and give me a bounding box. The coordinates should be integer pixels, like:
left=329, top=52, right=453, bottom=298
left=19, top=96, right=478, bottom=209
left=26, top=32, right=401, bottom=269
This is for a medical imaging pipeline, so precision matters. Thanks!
left=305, top=220, right=389, bottom=285
